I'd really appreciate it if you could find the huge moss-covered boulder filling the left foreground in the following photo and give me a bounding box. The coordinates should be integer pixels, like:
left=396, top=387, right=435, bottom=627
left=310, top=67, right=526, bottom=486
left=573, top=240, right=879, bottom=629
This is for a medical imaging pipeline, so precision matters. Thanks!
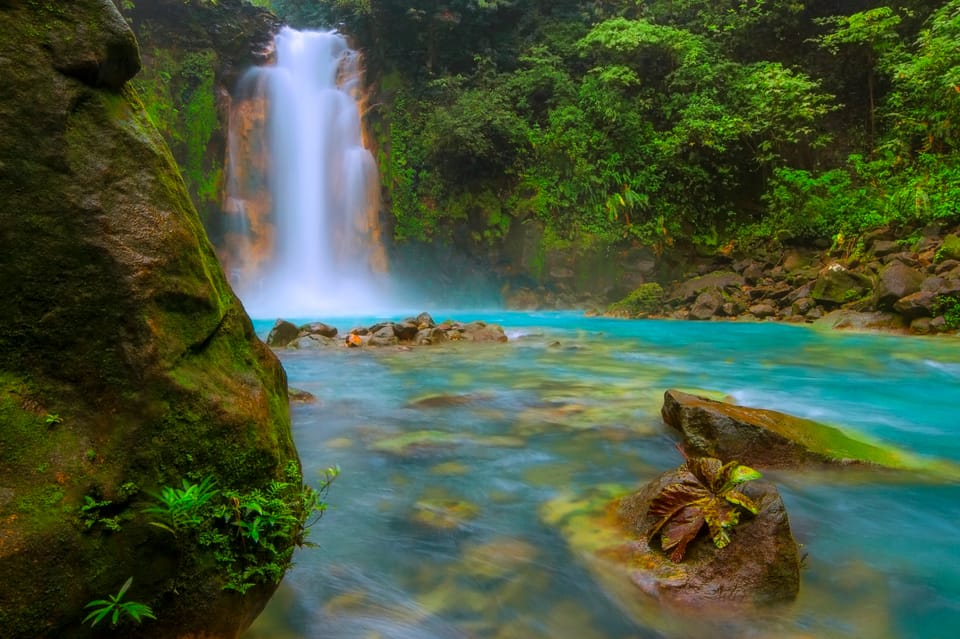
left=0, top=0, right=299, bottom=638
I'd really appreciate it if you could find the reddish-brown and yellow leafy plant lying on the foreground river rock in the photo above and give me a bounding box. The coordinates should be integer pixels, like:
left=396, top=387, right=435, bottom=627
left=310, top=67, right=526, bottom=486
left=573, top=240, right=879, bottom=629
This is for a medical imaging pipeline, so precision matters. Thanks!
left=650, top=450, right=760, bottom=562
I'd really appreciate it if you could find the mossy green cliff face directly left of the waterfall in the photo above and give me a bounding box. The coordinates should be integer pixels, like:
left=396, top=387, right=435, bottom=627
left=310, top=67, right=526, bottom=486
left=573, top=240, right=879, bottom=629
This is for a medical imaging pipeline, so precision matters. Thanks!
left=121, top=0, right=280, bottom=241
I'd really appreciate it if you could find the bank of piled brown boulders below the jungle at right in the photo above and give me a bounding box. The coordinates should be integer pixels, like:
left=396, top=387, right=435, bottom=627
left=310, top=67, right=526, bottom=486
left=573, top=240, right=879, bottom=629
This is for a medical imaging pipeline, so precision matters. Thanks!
left=506, top=227, right=960, bottom=335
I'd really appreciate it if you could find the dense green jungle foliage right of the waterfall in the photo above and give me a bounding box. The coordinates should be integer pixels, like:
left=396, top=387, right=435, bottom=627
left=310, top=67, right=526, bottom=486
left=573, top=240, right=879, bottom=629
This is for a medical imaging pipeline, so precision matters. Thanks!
left=244, top=0, right=960, bottom=258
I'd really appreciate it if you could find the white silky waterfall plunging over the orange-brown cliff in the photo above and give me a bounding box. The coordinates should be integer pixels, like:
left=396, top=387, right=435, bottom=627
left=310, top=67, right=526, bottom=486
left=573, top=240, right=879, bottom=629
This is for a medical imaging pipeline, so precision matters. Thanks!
left=224, top=28, right=386, bottom=317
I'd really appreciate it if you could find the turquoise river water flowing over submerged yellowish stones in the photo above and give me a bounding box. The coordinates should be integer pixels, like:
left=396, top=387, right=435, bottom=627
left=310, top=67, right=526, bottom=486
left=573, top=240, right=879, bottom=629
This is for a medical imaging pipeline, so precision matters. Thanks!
left=245, top=312, right=960, bottom=639
